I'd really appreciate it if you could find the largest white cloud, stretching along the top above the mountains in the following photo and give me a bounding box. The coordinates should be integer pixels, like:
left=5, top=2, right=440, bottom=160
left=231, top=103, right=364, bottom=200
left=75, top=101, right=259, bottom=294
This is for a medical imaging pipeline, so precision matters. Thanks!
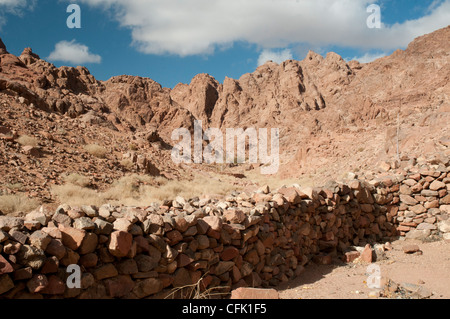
left=80, top=0, right=450, bottom=56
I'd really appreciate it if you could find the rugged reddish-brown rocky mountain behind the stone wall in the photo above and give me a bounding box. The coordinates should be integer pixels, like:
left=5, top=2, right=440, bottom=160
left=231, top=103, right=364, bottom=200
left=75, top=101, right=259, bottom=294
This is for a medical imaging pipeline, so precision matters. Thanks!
left=0, top=26, right=450, bottom=205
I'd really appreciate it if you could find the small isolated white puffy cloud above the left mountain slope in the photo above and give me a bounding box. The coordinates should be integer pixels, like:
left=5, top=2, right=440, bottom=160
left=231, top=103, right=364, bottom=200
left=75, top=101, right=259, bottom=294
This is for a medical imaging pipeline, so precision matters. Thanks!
left=47, top=40, right=102, bottom=65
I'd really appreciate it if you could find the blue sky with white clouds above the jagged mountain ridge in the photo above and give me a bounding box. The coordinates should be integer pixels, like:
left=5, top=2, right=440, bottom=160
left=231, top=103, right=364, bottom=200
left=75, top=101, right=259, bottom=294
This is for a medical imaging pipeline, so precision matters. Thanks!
left=0, top=0, right=450, bottom=87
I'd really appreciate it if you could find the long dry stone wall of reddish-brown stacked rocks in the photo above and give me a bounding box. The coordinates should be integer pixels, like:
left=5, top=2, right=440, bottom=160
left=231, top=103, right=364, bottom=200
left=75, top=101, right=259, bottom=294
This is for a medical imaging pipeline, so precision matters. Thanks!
left=0, top=162, right=450, bottom=299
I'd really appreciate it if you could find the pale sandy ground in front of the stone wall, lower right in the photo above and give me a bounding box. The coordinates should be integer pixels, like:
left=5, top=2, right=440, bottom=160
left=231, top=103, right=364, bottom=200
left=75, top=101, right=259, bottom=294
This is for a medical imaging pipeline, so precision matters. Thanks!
left=277, top=240, right=450, bottom=299
